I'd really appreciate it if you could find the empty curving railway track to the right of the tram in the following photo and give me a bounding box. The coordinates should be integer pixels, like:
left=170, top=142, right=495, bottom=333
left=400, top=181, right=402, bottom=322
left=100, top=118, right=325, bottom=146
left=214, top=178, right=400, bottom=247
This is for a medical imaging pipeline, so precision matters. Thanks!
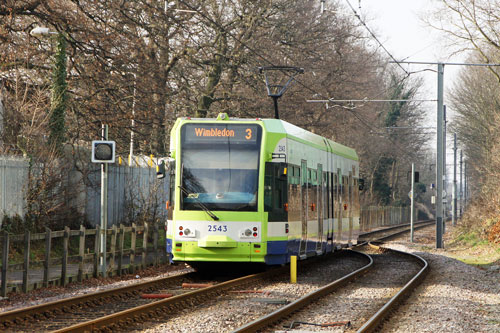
left=233, top=243, right=429, bottom=333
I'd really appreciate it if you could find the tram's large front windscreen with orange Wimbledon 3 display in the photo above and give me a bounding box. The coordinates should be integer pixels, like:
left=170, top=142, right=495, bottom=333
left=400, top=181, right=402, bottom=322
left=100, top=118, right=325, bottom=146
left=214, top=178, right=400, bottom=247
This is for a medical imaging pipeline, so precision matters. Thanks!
left=180, top=123, right=262, bottom=211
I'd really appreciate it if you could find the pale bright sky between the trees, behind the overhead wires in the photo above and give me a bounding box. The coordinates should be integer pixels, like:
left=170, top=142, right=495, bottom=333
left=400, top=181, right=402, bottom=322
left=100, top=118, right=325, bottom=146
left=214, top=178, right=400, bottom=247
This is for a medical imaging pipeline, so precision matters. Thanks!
left=345, top=0, right=464, bottom=140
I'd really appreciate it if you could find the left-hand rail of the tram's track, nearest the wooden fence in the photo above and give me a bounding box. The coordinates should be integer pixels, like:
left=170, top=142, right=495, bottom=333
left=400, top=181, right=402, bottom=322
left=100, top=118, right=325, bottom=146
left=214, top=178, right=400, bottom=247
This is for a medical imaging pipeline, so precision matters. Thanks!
left=0, top=272, right=194, bottom=327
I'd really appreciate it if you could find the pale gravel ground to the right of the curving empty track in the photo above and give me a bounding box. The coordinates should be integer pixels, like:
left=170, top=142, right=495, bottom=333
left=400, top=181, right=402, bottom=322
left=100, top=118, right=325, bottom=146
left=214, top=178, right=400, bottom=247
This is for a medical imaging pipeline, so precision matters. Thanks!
left=381, top=224, right=500, bottom=333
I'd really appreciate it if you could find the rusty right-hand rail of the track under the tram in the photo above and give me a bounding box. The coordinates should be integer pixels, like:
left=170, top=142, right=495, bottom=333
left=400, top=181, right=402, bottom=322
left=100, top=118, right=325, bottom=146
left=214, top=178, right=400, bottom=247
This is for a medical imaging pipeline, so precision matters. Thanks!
left=54, top=266, right=288, bottom=333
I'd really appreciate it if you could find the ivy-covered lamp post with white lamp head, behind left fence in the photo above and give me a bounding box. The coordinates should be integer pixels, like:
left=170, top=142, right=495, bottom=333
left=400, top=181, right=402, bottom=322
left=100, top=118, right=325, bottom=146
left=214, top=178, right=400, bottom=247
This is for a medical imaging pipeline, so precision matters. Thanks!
left=30, top=27, right=67, bottom=152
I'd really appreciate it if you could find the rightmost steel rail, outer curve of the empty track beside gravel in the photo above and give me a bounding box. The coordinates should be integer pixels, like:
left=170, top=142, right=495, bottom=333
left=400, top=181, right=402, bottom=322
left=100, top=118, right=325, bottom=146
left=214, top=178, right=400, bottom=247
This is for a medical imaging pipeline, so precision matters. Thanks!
left=357, top=241, right=429, bottom=333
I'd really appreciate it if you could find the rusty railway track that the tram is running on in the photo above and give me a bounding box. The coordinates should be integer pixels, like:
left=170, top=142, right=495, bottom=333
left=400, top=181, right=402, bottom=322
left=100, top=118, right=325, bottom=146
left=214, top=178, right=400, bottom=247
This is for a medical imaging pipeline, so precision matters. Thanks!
left=0, top=254, right=367, bottom=332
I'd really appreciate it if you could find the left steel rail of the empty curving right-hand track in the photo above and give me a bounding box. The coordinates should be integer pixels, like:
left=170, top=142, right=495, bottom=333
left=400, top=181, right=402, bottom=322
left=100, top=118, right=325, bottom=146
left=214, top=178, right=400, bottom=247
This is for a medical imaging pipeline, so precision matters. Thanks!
left=233, top=250, right=373, bottom=333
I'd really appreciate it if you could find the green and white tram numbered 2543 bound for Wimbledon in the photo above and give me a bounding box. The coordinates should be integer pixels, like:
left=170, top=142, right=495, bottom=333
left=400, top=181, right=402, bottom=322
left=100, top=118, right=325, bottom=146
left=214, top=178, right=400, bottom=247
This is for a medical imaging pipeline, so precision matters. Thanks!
left=166, top=114, right=359, bottom=265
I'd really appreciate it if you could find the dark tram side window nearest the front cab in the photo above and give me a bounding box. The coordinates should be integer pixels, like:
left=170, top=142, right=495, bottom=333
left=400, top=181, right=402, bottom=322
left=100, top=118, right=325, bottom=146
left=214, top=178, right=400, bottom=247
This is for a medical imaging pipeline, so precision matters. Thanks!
left=264, top=162, right=288, bottom=222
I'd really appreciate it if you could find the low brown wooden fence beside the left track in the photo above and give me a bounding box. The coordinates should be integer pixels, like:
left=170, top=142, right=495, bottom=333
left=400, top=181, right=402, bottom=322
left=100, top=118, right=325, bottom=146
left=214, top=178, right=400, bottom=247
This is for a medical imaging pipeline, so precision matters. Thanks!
left=0, top=223, right=168, bottom=297
